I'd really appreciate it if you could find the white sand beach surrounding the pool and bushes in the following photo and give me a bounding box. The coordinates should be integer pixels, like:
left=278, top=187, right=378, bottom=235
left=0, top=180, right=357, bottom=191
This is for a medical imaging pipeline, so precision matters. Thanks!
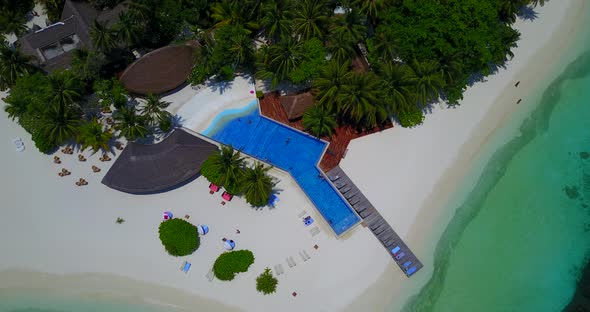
left=0, top=0, right=586, bottom=311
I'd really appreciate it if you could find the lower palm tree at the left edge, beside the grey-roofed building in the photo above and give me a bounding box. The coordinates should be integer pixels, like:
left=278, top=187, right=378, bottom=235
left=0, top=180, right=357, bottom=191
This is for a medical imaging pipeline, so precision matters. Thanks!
left=0, top=42, right=35, bottom=90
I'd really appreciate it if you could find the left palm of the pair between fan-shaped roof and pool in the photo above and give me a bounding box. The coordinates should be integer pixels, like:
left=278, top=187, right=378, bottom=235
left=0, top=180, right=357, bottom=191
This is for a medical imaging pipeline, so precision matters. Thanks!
left=201, top=145, right=244, bottom=195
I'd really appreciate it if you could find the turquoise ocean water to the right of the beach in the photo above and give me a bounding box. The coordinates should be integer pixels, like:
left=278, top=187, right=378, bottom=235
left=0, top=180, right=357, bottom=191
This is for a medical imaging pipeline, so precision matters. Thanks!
left=404, top=11, right=590, bottom=312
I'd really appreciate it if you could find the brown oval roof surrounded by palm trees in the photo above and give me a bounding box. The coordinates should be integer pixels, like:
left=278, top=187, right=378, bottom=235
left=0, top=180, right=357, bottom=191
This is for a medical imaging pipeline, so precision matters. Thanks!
left=119, top=45, right=195, bottom=94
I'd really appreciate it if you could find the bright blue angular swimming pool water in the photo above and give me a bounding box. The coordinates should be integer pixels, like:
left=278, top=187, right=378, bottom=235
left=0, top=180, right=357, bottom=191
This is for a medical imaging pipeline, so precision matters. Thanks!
left=208, top=104, right=360, bottom=235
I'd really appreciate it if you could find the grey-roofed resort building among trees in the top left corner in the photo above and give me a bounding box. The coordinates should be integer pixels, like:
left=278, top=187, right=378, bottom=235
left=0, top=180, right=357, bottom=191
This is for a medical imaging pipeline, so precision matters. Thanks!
left=18, top=0, right=126, bottom=72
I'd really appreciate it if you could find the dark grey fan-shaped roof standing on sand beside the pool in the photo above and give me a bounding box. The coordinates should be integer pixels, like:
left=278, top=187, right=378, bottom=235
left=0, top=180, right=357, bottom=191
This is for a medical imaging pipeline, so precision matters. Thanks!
left=102, top=129, right=218, bottom=194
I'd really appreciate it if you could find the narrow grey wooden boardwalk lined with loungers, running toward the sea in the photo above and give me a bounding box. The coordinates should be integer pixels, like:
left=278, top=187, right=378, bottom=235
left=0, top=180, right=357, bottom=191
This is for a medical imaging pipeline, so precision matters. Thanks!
left=327, top=166, right=423, bottom=277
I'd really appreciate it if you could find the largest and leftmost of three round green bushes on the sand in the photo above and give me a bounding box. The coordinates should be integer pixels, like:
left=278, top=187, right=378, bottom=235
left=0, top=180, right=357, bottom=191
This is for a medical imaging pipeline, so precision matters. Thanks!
left=159, top=219, right=199, bottom=257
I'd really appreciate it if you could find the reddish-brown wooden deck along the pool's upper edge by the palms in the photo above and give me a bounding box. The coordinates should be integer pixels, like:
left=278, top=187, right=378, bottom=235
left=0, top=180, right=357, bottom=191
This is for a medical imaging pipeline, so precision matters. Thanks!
left=260, top=92, right=393, bottom=171
